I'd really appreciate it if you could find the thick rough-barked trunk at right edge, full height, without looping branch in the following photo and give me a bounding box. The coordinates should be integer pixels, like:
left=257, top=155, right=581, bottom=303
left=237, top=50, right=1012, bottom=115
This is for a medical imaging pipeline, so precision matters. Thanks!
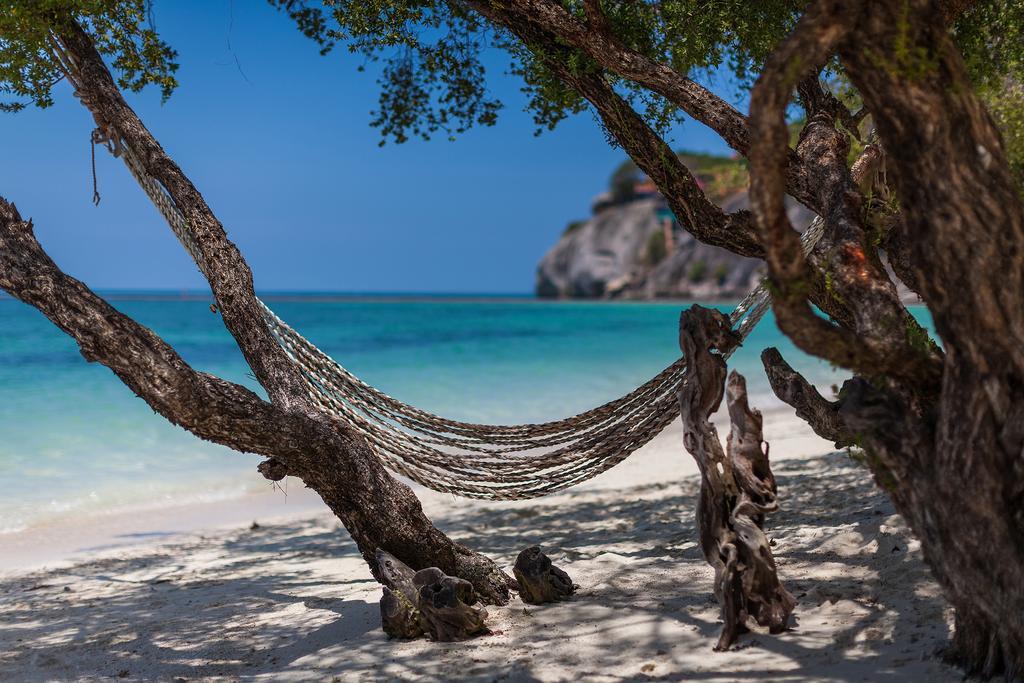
left=841, top=0, right=1024, bottom=680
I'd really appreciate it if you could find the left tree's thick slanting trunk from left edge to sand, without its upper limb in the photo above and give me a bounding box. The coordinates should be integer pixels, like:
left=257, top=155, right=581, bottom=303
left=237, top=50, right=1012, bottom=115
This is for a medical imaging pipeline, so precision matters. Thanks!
left=0, top=200, right=508, bottom=603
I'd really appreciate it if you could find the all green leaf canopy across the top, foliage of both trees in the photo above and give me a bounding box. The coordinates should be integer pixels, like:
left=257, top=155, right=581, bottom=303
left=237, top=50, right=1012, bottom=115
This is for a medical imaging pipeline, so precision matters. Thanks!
left=0, top=0, right=1024, bottom=168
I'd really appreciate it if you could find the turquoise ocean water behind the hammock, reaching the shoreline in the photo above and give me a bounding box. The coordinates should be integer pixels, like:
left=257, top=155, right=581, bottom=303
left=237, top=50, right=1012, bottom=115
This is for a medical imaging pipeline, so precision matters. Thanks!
left=0, top=294, right=880, bottom=533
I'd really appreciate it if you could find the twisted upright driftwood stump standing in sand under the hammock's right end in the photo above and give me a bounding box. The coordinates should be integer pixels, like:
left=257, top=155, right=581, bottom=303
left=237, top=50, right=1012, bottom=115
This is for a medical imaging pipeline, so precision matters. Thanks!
left=679, top=305, right=796, bottom=650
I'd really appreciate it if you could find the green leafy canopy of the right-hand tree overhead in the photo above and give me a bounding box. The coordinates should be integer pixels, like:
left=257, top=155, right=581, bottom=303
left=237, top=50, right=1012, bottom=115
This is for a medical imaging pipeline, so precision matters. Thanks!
left=269, top=0, right=1024, bottom=152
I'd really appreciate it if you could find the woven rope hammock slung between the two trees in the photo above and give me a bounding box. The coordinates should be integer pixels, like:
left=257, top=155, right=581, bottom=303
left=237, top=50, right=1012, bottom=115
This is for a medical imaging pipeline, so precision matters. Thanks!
left=54, top=45, right=823, bottom=500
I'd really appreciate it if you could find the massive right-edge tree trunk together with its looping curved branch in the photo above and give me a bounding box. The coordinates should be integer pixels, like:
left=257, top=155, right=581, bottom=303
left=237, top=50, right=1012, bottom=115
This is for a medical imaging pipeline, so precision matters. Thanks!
left=751, top=0, right=1024, bottom=680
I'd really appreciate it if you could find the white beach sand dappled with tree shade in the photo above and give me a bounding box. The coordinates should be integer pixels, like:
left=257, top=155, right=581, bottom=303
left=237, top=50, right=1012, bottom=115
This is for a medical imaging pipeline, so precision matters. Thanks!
left=0, top=415, right=959, bottom=683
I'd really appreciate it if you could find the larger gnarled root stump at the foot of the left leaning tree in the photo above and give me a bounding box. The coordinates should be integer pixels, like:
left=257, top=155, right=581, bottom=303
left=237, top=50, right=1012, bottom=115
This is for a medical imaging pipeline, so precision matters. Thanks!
left=377, top=550, right=487, bottom=642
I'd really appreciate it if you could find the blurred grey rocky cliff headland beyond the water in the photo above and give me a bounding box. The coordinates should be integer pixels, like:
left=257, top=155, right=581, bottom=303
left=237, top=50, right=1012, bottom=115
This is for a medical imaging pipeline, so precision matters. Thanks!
left=537, top=188, right=813, bottom=299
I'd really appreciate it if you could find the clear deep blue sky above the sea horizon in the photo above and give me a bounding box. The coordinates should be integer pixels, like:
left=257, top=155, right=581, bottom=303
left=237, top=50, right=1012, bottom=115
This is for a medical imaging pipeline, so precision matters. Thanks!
left=0, top=0, right=728, bottom=293
